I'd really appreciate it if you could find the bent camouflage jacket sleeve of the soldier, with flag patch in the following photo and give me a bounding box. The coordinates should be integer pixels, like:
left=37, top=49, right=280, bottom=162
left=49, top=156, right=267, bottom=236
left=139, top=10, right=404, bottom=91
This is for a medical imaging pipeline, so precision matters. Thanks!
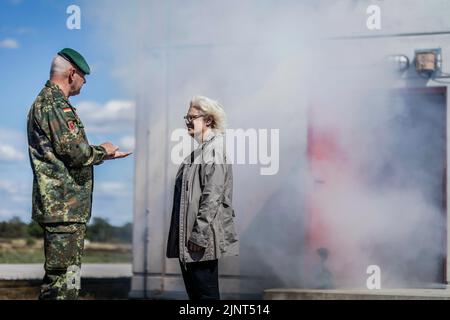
left=40, top=106, right=107, bottom=168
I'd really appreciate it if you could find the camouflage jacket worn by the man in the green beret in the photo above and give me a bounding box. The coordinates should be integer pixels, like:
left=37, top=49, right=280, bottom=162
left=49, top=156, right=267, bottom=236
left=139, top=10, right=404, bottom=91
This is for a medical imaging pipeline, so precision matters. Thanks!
left=27, top=81, right=106, bottom=223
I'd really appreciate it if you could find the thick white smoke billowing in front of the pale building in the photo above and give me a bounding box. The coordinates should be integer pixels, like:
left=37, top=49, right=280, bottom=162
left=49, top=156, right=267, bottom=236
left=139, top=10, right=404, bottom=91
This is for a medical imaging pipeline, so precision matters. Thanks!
left=89, top=0, right=448, bottom=288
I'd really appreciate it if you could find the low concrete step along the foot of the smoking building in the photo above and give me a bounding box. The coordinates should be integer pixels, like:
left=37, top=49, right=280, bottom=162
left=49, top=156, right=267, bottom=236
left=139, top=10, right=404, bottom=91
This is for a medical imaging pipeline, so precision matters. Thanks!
left=264, top=289, right=450, bottom=300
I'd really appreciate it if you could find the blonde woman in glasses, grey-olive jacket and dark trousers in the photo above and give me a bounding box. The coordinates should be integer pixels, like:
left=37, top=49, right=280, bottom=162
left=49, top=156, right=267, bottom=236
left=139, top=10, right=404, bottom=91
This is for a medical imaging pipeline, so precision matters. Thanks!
left=167, top=96, right=239, bottom=300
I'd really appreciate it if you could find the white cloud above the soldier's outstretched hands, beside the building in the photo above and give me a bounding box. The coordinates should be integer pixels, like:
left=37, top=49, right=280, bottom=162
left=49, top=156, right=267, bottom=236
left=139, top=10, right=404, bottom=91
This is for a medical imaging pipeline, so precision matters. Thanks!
left=77, top=100, right=135, bottom=133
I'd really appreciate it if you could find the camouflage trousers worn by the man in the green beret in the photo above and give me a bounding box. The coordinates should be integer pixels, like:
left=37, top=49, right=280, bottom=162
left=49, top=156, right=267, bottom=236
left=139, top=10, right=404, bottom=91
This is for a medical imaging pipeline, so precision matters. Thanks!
left=39, top=223, right=86, bottom=300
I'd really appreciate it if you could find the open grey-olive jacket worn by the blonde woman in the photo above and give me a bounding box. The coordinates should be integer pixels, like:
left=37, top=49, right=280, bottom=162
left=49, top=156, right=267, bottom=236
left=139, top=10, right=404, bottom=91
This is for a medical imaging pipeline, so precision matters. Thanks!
left=167, top=132, right=239, bottom=262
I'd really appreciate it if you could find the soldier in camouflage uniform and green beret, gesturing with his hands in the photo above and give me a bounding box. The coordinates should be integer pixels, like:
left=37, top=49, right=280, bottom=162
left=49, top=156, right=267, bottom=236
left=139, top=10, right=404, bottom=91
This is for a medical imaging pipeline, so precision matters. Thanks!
left=27, top=48, right=131, bottom=299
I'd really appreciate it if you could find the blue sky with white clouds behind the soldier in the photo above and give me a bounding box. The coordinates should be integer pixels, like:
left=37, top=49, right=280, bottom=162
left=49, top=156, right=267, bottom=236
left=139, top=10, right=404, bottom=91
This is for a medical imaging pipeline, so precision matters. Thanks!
left=0, top=0, right=134, bottom=225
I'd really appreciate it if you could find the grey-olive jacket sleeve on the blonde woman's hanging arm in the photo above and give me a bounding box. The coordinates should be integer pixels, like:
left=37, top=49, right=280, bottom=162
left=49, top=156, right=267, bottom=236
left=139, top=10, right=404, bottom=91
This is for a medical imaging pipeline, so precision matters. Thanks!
left=189, top=147, right=227, bottom=248
